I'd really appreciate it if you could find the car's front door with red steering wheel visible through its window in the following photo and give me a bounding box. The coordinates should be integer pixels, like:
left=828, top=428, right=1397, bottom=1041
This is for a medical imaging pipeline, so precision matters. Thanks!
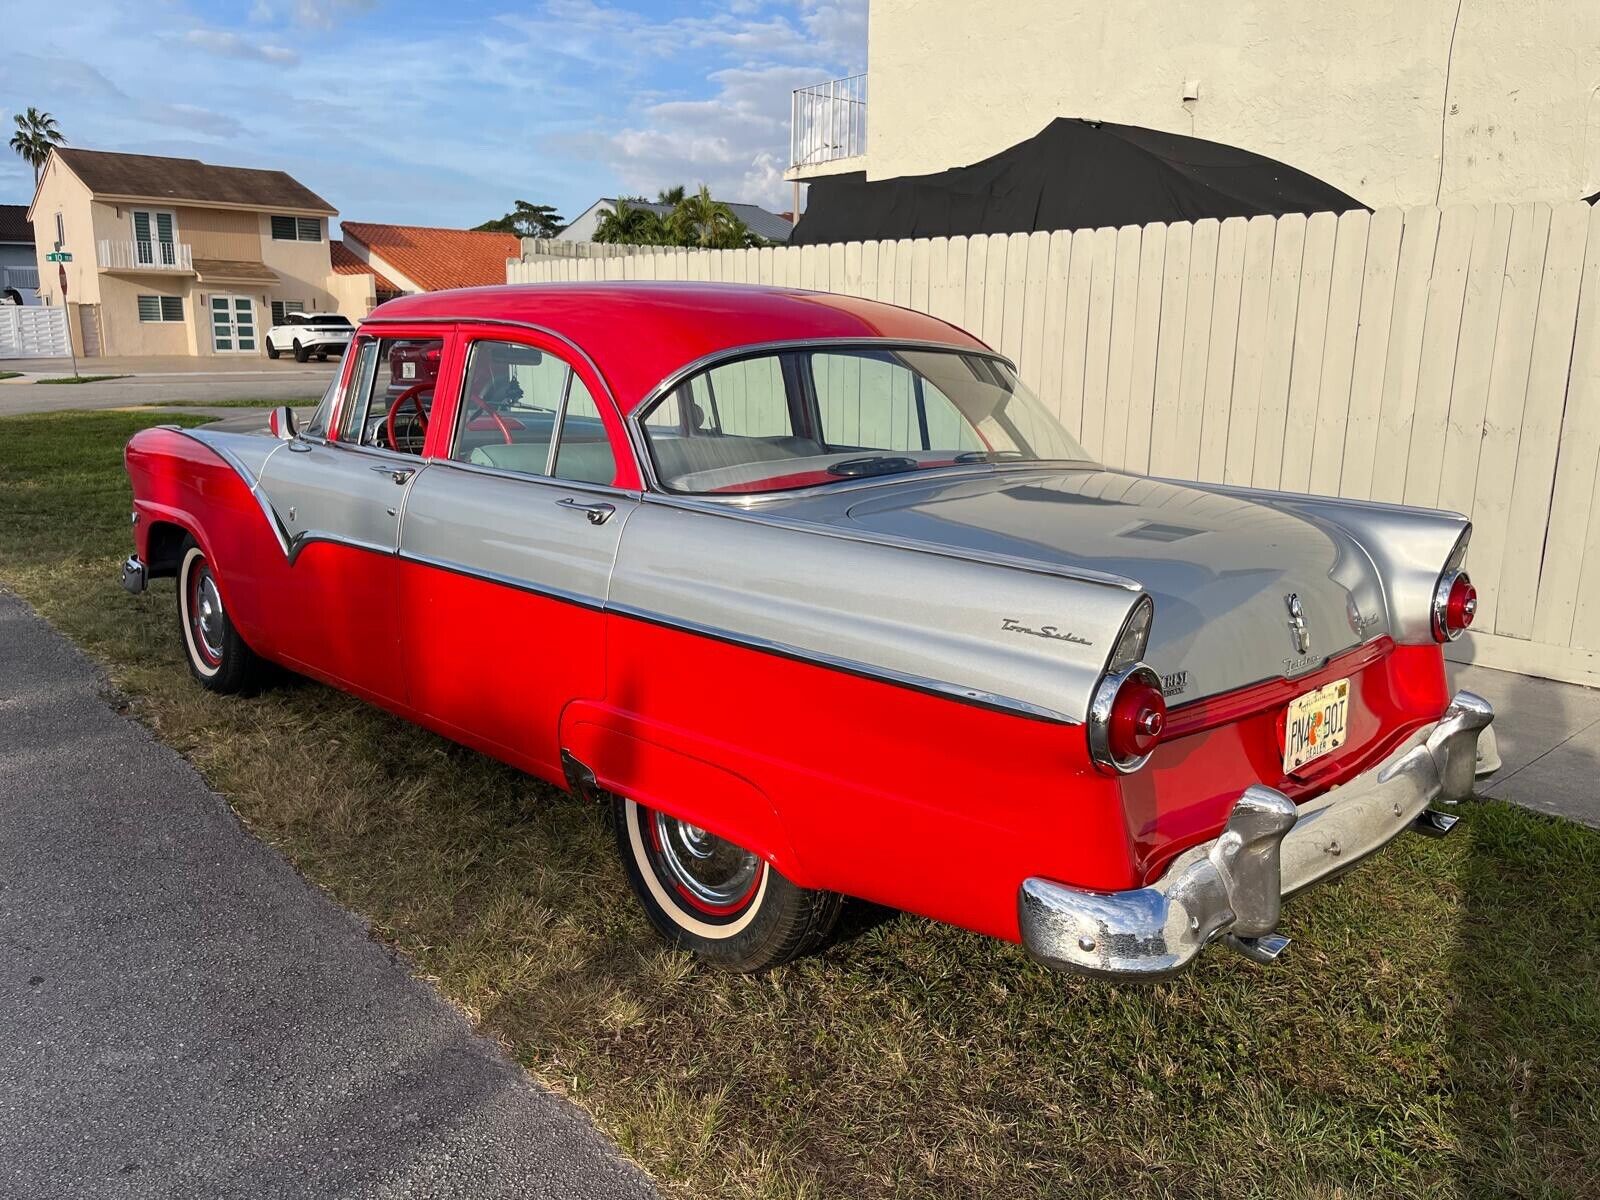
left=261, top=326, right=450, bottom=707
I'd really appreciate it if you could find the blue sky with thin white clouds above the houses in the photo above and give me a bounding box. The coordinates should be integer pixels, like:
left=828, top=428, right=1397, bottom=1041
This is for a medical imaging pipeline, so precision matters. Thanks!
left=0, top=0, right=867, bottom=226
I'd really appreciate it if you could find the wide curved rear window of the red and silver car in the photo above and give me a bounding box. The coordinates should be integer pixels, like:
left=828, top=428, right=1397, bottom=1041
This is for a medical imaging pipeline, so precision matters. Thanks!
left=642, top=347, right=1088, bottom=494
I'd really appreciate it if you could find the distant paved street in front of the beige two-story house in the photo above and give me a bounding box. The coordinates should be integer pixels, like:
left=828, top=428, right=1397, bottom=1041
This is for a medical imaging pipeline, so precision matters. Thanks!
left=0, top=358, right=339, bottom=416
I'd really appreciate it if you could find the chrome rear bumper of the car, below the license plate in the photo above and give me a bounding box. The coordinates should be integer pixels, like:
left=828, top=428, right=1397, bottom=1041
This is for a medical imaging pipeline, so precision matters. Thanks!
left=1018, top=691, right=1499, bottom=979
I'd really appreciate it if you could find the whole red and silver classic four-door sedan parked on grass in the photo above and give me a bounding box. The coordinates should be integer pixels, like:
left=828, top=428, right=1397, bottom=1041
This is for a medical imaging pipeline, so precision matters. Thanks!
left=123, top=283, right=1498, bottom=978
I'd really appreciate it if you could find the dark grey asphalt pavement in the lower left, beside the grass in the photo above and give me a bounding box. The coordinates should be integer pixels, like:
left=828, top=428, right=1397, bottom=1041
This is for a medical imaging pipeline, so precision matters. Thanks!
left=0, top=594, right=651, bottom=1200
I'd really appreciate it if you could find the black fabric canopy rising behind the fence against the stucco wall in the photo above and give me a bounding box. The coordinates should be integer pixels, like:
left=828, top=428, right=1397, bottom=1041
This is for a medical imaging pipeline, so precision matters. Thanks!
left=789, top=117, right=1365, bottom=246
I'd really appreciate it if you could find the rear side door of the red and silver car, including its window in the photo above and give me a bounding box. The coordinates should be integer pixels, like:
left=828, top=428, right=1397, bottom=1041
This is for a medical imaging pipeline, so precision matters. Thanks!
left=400, top=331, right=638, bottom=778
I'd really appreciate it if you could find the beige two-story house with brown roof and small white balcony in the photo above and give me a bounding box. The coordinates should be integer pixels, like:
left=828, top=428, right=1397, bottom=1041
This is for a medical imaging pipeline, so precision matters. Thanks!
left=29, top=149, right=373, bottom=355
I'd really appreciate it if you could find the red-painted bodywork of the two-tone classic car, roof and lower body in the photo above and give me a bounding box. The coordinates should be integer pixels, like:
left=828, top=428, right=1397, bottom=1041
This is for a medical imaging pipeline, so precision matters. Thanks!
left=126, top=285, right=1448, bottom=941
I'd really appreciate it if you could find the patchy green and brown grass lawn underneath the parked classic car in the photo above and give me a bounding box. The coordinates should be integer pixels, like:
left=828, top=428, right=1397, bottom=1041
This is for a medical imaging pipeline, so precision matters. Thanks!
left=0, top=413, right=1600, bottom=1200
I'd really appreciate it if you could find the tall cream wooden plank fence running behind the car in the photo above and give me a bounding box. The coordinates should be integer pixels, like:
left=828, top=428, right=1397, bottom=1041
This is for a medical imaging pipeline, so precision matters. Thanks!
left=507, top=202, right=1600, bottom=685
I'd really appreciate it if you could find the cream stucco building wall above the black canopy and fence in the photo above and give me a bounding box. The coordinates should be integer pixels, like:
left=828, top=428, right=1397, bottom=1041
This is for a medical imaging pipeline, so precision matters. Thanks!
left=867, top=0, right=1600, bottom=206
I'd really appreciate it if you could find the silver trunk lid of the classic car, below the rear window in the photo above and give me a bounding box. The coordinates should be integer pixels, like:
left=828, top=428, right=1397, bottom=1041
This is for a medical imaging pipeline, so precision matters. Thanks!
left=774, top=469, right=1389, bottom=704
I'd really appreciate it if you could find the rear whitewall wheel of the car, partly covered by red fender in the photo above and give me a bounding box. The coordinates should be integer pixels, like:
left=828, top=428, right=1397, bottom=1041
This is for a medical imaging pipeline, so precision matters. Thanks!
left=611, top=797, right=843, bottom=971
